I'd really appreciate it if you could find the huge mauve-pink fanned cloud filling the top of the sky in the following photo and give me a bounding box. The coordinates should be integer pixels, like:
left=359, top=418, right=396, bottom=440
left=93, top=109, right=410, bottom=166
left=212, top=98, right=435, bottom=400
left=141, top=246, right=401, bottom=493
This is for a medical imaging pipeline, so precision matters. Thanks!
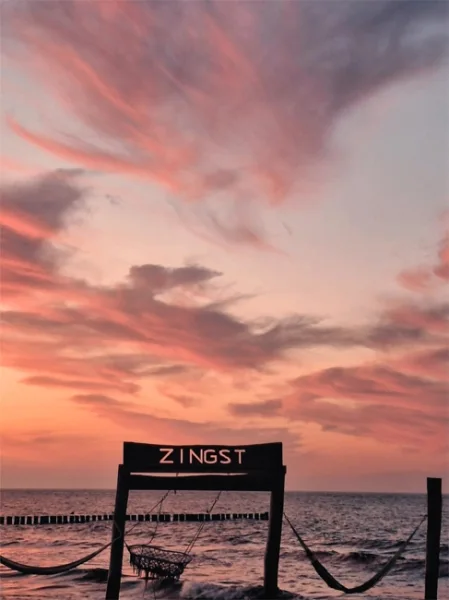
left=2, top=0, right=448, bottom=248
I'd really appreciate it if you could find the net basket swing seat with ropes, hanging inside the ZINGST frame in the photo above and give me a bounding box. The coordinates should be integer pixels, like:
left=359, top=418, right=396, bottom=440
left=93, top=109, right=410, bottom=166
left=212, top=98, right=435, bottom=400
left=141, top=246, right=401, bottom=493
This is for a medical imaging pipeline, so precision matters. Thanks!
left=125, top=492, right=221, bottom=580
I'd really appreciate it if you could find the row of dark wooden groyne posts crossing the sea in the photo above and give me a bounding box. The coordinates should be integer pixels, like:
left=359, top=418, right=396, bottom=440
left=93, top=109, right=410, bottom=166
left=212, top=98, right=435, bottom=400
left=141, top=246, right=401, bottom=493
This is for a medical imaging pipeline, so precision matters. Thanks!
left=0, top=512, right=269, bottom=525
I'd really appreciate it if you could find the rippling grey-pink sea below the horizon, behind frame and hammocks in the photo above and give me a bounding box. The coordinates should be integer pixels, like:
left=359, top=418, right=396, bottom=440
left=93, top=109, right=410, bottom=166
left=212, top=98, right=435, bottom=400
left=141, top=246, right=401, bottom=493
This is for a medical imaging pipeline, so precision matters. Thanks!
left=0, top=490, right=449, bottom=600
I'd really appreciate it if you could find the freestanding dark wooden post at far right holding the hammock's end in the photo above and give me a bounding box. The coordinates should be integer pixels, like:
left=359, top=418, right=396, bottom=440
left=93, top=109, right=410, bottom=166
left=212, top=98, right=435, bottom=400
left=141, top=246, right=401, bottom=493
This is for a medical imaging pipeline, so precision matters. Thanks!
left=424, top=477, right=443, bottom=600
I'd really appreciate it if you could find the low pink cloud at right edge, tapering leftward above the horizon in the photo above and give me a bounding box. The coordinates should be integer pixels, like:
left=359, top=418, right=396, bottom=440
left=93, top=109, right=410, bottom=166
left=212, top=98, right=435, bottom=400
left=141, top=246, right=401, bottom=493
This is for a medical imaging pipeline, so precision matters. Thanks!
left=284, top=359, right=449, bottom=452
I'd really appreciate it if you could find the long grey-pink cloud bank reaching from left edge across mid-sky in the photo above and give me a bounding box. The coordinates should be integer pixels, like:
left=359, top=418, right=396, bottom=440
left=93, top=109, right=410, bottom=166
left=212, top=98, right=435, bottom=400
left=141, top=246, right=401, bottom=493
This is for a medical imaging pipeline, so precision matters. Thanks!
left=0, top=172, right=378, bottom=394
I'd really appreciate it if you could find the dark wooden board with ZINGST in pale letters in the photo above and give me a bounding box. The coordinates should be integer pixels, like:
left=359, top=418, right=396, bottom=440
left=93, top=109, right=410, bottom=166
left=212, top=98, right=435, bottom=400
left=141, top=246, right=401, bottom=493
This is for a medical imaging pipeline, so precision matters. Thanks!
left=123, top=442, right=282, bottom=473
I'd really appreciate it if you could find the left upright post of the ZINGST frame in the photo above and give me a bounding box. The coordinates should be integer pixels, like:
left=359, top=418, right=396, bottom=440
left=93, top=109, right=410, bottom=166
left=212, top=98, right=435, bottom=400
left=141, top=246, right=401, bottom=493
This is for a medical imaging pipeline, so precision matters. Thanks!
left=106, top=465, right=129, bottom=600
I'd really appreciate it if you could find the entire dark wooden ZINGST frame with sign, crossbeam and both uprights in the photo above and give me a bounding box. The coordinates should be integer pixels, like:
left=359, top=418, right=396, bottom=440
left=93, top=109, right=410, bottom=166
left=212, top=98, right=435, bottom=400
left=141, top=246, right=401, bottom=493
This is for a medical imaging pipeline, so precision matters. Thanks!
left=106, top=442, right=286, bottom=600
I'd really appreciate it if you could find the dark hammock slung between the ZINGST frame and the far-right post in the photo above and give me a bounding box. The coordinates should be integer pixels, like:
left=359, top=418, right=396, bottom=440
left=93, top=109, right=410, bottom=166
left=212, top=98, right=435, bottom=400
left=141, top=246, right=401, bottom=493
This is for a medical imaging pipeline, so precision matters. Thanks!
left=284, top=513, right=427, bottom=594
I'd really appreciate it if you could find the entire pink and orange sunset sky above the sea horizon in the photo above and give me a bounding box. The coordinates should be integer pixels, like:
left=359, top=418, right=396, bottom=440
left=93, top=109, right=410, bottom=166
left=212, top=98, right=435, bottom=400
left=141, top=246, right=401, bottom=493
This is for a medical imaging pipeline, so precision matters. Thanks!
left=0, top=0, right=449, bottom=492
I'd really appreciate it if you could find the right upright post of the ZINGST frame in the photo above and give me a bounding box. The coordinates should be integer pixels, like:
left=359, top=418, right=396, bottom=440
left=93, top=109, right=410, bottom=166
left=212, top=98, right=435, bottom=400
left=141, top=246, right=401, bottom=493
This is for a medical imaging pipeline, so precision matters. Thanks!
left=264, top=472, right=285, bottom=598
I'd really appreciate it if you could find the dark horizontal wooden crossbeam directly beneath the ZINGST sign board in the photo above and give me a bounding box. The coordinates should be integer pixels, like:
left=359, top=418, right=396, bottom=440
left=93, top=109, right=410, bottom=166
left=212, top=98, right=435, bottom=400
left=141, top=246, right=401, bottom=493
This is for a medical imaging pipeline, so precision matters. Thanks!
left=129, top=471, right=274, bottom=492
